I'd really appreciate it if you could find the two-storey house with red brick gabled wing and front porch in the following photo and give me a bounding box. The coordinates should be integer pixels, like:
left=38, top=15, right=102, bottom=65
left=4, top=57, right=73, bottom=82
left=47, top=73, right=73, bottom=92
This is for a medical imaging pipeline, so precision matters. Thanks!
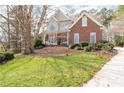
left=43, top=9, right=103, bottom=45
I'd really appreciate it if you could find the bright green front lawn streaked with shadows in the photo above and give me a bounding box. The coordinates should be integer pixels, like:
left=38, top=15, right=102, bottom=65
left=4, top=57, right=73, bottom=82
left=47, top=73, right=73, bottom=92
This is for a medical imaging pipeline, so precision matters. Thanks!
left=0, top=53, right=110, bottom=86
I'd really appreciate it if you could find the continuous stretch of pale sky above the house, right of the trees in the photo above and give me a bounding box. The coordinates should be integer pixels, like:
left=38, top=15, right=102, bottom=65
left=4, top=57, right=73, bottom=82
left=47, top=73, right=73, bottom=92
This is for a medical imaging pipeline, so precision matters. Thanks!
left=44, top=5, right=118, bottom=16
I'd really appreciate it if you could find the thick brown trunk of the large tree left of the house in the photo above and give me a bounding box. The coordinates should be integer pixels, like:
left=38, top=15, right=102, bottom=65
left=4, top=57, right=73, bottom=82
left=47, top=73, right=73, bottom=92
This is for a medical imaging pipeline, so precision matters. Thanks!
left=21, top=6, right=33, bottom=54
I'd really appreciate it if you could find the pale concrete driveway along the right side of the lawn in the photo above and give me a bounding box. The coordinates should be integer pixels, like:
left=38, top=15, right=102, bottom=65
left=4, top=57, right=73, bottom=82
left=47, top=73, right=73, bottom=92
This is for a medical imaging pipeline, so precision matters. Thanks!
left=84, top=47, right=124, bottom=87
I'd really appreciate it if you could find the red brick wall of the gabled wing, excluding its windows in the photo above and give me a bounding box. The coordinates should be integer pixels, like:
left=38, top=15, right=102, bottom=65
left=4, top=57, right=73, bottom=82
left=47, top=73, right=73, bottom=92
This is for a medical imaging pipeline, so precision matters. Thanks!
left=69, top=15, right=102, bottom=44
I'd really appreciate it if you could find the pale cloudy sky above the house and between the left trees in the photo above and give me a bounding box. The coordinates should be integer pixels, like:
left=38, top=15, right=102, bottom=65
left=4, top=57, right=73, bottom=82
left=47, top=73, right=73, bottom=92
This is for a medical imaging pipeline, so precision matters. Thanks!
left=0, top=5, right=117, bottom=14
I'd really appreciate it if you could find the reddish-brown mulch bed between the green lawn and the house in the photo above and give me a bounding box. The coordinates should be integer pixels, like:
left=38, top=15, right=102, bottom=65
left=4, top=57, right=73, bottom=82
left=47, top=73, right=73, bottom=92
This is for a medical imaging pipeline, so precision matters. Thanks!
left=16, top=46, right=117, bottom=57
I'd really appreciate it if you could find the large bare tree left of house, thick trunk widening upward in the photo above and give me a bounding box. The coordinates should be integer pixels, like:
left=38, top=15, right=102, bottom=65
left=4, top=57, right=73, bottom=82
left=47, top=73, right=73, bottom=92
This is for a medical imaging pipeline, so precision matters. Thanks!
left=14, top=5, right=33, bottom=54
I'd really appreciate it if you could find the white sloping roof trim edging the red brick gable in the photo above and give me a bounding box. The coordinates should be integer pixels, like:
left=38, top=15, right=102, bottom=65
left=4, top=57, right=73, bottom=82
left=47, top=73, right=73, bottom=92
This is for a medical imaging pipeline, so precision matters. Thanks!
left=69, top=12, right=103, bottom=28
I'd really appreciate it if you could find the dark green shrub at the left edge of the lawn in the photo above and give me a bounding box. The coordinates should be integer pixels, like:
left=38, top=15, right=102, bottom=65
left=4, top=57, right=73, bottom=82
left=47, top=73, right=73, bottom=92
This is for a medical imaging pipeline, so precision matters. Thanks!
left=0, top=53, right=14, bottom=63
